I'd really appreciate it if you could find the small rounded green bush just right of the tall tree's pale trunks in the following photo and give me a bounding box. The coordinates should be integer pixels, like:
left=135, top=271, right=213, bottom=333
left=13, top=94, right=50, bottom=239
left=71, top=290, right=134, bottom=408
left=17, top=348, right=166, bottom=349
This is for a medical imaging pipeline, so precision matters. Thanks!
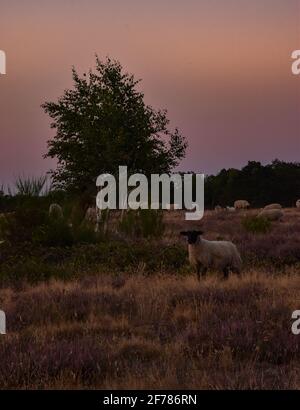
left=119, top=209, right=165, bottom=238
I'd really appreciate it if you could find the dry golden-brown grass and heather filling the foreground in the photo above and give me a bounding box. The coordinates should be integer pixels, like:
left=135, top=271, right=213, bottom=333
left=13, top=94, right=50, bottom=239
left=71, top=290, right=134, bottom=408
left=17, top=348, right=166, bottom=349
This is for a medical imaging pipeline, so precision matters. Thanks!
left=0, top=272, right=300, bottom=389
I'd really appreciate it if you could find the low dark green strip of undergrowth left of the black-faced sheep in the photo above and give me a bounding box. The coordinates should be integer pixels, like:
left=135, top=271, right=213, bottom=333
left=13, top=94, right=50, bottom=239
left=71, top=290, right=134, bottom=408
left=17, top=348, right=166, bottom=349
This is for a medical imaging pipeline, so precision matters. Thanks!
left=0, top=237, right=187, bottom=287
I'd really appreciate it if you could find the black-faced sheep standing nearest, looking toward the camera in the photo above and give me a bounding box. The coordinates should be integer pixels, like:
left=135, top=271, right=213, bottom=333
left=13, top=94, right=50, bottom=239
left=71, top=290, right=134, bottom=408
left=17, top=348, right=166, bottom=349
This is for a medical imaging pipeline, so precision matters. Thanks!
left=180, top=231, right=242, bottom=280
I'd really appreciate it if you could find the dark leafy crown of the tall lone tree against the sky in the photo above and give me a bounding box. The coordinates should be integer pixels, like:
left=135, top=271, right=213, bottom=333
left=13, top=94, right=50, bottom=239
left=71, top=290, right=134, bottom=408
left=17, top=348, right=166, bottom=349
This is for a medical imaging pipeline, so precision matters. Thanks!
left=42, top=57, right=187, bottom=193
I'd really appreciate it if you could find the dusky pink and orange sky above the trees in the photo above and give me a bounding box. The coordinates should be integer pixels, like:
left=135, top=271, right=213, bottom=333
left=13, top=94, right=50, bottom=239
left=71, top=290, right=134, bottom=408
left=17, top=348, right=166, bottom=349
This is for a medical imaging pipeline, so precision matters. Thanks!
left=0, top=0, right=300, bottom=184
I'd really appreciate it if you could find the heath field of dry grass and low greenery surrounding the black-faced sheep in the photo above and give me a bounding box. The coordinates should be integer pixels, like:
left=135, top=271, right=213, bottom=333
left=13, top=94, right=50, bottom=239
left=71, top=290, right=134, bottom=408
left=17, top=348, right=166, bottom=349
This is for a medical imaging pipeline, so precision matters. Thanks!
left=0, top=209, right=300, bottom=389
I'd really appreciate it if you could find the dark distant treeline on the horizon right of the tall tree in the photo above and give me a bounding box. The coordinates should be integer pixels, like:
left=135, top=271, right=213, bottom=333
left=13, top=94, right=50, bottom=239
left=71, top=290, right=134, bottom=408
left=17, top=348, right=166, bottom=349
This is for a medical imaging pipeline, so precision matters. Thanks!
left=205, top=160, right=300, bottom=208
